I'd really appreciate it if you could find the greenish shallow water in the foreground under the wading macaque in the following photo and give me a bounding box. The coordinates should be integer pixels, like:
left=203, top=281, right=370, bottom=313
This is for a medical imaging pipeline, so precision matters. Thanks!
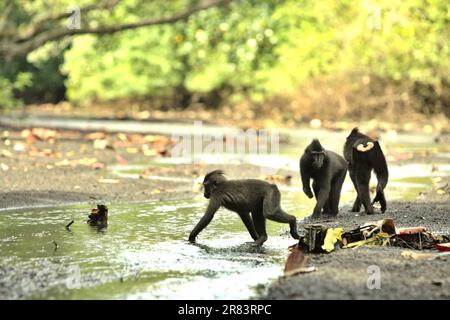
left=0, top=199, right=295, bottom=299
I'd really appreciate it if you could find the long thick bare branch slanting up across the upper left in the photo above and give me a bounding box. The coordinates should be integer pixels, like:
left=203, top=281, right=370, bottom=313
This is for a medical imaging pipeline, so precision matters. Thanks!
left=0, top=0, right=232, bottom=58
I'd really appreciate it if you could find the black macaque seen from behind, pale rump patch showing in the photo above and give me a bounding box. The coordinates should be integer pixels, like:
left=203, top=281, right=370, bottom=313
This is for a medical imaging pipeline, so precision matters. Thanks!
left=344, top=128, right=389, bottom=214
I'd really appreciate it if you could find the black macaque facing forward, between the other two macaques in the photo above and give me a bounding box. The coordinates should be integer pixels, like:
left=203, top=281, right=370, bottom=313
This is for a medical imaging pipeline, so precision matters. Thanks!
left=300, top=139, right=347, bottom=219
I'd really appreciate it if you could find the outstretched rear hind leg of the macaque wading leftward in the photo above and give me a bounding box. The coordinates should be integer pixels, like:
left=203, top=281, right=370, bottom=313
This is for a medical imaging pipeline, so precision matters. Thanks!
left=263, top=186, right=300, bottom=239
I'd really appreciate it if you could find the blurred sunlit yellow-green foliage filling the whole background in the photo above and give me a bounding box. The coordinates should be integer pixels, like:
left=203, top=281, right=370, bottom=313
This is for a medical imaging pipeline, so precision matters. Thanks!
left=0, top=0, right=450, bottom=113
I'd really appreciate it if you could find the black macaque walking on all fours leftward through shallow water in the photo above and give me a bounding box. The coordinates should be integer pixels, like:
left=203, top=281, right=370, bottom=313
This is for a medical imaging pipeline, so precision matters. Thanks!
left=189, top=170, right=300, bottom=245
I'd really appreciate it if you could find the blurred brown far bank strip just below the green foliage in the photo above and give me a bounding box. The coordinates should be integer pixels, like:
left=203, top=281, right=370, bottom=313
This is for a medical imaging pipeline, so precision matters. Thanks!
left=4, top=102, right=450, bottom=135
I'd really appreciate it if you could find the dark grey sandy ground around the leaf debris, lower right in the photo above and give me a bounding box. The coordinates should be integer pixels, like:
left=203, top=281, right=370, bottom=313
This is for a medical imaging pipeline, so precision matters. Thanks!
left=263, top=201, right=450, bottom=300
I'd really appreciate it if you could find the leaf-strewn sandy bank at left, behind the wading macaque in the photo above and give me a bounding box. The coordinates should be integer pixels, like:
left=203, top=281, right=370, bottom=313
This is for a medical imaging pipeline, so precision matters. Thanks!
left=0, top=127, right=296, bottom=210
